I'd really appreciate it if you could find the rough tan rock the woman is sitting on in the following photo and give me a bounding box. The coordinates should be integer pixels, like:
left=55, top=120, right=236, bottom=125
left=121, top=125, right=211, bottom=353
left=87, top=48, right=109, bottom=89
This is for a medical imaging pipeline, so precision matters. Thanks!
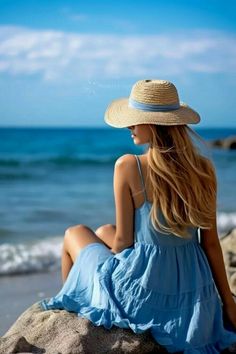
left=0, top=302, right=167, bottom=354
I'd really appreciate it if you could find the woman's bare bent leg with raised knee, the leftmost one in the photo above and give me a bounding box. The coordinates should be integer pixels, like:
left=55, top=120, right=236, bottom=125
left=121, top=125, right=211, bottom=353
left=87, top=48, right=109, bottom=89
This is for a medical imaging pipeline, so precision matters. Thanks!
left=61, top=225, right=104, bottom=283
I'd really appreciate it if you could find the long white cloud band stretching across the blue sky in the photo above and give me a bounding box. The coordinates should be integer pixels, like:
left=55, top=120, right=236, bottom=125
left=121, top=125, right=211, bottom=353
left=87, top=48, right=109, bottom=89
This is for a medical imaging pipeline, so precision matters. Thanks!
left=0, top=26, right=236, bottom=81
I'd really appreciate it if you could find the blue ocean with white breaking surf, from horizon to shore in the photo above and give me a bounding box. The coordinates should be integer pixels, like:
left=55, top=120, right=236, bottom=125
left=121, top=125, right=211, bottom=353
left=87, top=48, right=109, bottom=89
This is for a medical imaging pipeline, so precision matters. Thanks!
left=0, top=127, right=236, bottom=275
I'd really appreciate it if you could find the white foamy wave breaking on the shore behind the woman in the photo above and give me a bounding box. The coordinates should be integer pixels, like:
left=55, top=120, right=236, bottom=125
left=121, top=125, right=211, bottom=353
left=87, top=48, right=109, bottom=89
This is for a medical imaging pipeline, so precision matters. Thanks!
left=0, top=212, right=236, bottom=276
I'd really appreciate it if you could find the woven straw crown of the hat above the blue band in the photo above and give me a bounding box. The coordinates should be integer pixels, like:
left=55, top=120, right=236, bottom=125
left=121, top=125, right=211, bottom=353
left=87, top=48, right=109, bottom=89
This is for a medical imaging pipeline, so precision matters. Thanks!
left=130, top=80, right=179, bottom=105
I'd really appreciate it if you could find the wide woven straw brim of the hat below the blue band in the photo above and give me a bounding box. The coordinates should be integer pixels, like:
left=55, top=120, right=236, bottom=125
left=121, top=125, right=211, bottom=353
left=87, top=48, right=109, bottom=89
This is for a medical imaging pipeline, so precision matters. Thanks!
left=104, top=98, right=200, bottom=128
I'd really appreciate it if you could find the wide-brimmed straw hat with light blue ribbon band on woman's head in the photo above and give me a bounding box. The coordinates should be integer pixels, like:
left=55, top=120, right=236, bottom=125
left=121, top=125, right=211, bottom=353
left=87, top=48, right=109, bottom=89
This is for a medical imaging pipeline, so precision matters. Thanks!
left=104, top=80, right=200, bottom=128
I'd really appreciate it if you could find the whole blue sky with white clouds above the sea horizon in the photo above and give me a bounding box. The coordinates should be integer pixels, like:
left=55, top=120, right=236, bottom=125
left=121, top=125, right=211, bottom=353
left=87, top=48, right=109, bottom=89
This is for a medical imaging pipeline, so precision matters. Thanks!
left=0, top=0, right=236, bottom=127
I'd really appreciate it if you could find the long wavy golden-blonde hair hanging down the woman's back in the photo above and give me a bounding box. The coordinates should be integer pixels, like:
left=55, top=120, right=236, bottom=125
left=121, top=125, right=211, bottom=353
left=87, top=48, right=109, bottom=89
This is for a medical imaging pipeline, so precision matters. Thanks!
left=147, top=124, right=217, bottom=237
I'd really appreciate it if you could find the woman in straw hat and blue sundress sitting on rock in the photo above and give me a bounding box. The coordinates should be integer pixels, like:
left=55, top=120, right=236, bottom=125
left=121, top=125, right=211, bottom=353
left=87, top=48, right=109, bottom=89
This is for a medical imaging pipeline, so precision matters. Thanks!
left=42, top=80, right=236, bottom=354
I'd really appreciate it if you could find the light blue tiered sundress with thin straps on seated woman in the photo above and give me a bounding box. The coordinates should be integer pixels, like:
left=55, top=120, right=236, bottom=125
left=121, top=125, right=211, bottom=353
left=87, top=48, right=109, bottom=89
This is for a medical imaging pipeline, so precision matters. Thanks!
left=40, top=155, right=236, bottom=354
